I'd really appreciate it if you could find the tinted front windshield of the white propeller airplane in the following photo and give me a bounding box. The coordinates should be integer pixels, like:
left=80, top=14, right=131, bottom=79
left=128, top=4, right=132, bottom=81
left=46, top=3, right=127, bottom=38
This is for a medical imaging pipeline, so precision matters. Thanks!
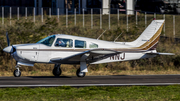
left=37, top=35, right=55, bottom=46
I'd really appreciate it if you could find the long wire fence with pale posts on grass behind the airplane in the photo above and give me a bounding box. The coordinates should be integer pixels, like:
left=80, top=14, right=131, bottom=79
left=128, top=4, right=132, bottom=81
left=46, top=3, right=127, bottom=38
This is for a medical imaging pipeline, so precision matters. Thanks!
left=0, top=7, right=180, bottom=38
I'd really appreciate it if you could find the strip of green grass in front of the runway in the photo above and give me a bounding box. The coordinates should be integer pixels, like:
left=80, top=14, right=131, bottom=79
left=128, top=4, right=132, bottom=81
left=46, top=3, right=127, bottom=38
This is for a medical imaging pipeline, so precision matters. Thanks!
left=0, top=85, right=180, bottom=101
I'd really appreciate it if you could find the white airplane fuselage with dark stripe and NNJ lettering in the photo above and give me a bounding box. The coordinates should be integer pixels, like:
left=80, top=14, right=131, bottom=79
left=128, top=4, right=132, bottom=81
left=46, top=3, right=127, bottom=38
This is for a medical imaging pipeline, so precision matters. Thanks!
left=13, top=34, right=156, bottom=65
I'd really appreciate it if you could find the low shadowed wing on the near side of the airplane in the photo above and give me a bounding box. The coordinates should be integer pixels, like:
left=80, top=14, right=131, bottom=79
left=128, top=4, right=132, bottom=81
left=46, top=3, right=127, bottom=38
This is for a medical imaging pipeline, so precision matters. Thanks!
left=50, top=49, right=122, bottom=63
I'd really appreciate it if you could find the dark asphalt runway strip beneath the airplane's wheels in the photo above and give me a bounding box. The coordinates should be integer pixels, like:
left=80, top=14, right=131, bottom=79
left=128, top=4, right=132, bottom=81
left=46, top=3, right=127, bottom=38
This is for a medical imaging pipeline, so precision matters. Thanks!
left=0, top=75, right=180, bottom=87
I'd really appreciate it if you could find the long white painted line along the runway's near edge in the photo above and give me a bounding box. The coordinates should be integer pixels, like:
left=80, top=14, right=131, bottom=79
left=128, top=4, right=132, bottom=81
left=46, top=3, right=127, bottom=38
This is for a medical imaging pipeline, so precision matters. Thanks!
left=0, top=83, right=180, bottom=88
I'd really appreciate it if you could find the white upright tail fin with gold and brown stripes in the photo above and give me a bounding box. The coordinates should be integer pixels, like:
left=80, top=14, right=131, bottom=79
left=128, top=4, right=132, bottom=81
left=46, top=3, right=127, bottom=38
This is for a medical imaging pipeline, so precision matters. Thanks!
left=127, top=20, right=164, bottom=50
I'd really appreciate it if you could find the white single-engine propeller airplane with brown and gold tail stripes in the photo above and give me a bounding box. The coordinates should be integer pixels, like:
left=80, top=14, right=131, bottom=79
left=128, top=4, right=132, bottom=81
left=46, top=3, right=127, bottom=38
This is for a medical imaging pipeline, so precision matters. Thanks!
left=3, top=20, right=174, bottom=77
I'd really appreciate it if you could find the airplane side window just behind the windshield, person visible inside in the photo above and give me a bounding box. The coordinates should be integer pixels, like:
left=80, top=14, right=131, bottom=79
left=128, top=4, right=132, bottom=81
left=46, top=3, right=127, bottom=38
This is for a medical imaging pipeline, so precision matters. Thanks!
left=55, top=38, right=73, bottom=48
